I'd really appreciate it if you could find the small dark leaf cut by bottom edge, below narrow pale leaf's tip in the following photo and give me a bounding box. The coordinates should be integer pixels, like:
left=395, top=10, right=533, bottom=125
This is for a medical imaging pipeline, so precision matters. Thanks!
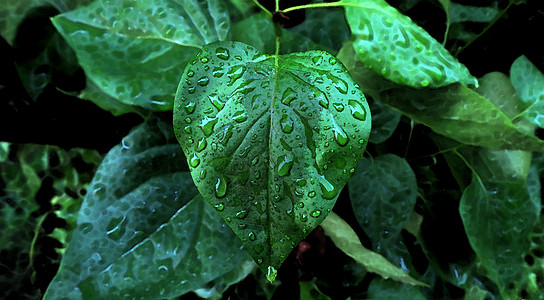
left=367, top=277, right=427, bottom=300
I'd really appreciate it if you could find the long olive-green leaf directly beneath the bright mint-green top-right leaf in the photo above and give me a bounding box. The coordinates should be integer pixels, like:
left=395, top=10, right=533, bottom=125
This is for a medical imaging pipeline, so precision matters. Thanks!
left=338, top=43, right=544, bottom=151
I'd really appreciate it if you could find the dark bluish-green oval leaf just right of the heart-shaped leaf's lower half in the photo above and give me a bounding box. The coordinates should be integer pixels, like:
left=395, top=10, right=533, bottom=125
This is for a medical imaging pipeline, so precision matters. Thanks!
left=349, top=154, right=417, bottom=251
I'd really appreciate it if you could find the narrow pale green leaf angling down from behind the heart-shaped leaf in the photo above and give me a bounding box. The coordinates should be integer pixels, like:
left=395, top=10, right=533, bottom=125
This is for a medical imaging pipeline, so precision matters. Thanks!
left=321, top=212, right=427, bottom=286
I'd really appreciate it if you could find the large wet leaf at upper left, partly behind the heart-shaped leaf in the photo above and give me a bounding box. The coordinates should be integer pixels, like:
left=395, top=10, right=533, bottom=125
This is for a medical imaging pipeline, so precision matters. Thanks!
left=52, top=0, right=230, bottom=111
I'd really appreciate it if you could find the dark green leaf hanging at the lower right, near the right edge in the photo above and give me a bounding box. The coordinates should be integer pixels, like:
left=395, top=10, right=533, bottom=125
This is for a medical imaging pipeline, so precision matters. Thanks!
left=459, top=178, right=540, bottom=299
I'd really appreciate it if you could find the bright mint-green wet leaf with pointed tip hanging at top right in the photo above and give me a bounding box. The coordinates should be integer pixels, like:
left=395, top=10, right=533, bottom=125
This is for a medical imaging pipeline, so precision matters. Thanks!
left=341, top=0, right=478, bottom=88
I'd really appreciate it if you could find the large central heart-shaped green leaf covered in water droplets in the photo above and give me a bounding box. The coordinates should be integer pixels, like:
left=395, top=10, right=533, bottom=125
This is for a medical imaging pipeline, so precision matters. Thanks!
left=174, top=42, right=371, bottom=278
